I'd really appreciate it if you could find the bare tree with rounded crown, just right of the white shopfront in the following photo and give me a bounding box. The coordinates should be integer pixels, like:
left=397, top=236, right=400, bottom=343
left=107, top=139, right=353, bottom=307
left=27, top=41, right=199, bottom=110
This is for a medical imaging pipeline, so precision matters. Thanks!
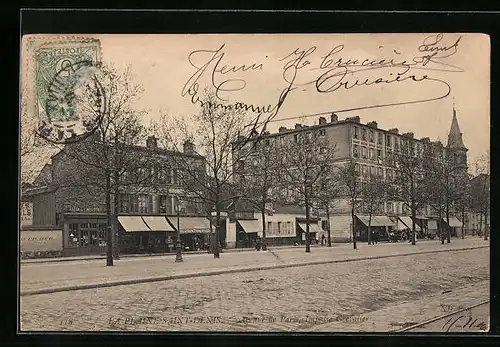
left=276, top=128, right=337, bottom=253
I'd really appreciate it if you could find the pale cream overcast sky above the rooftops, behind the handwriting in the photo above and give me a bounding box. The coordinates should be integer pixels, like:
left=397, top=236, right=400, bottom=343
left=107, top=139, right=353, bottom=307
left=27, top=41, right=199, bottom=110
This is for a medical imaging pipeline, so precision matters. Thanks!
left=97, top=34, right=490, bottom=167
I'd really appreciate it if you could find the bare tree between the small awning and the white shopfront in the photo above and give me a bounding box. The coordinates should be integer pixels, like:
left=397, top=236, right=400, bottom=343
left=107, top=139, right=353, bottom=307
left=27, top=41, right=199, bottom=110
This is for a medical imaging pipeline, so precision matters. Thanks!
left=233, top=138, right=278, bottom=250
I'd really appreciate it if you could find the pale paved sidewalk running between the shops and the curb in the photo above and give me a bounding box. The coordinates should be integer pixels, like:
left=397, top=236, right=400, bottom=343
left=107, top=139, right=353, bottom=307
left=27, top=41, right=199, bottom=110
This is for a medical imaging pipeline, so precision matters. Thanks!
left=21, top=239, right=489, bottom=295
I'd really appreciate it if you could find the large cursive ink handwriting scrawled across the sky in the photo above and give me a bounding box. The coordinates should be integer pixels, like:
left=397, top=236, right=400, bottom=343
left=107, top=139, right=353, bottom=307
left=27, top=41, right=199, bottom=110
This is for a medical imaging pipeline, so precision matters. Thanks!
left=181, top=34, right=464, bottom=118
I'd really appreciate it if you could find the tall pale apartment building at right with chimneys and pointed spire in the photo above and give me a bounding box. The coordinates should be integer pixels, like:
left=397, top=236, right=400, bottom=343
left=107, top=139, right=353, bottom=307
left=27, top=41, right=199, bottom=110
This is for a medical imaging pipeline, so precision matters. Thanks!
left=233, top=110, right=467, bottom=240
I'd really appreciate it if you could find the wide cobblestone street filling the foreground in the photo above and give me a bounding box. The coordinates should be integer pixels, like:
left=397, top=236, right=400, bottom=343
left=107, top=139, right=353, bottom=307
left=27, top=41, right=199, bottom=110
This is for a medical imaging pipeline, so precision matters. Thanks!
left=21, top=240, right=489, bottom=332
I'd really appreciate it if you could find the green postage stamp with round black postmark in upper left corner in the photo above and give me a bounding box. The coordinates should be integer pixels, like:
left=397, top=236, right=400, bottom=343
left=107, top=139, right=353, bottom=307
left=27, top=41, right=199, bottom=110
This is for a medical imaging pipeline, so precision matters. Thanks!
left=23, top=35, right=101, bottom=143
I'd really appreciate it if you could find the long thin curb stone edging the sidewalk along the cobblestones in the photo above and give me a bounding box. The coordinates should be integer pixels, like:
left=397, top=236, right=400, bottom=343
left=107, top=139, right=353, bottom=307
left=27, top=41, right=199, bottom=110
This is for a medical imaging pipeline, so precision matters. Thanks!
left=20, top=246, right=489, bottom=296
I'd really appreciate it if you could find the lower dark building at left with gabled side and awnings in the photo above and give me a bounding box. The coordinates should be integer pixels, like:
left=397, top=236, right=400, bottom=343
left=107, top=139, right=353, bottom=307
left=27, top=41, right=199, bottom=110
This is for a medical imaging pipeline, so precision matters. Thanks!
left=22, top=137, right=210, bottom=255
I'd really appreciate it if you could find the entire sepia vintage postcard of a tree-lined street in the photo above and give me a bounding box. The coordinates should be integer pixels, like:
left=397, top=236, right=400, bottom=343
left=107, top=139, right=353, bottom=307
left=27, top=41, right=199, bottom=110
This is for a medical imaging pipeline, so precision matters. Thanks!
left=19, top=33, right=490, bottom=333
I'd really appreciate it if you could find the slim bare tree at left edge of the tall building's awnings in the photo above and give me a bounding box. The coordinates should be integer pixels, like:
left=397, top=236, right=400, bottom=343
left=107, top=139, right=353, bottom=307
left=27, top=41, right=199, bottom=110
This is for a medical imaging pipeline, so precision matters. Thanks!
left=339, top=159, right=362, bottom=249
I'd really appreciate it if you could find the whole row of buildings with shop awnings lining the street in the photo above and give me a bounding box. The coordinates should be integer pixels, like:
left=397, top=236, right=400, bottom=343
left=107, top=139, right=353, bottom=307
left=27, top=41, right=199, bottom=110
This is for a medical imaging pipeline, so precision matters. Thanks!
left=21, top=110, right=484, bottom=255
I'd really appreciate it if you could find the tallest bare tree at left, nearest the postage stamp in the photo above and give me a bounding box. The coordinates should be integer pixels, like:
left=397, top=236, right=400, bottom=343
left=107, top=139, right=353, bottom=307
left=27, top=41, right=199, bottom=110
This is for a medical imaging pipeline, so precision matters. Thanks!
left=46, top=65, right=152, bottom=266
